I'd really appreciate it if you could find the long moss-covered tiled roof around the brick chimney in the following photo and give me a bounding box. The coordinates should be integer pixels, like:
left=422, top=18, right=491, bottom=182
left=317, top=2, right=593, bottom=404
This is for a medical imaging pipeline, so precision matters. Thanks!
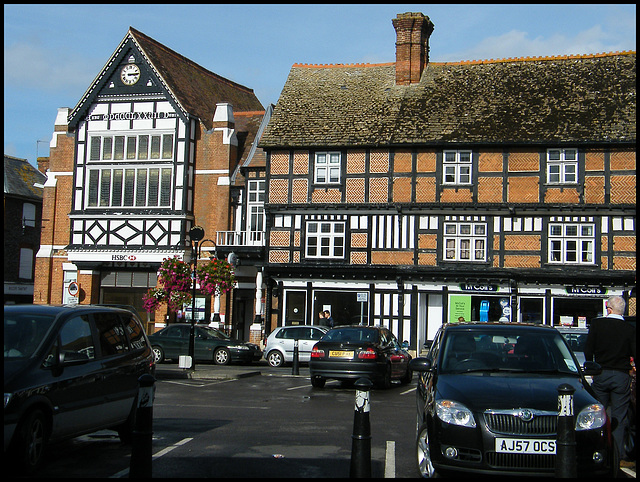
left=260, top=52, right=636, bottom=148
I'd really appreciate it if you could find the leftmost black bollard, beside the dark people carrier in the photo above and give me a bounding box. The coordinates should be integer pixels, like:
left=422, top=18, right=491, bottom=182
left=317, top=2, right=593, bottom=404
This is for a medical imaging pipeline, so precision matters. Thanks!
left=129, top=374, right=156, bottom=479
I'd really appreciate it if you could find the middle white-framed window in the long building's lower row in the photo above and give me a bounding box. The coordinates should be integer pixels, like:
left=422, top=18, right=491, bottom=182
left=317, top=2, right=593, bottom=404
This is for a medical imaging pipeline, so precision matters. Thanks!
left=442, top=221, right=488, bottom=263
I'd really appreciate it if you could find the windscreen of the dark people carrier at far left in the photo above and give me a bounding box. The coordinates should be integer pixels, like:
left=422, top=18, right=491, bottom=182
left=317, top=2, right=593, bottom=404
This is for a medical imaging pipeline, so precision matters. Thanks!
left=4, top=312, right=55, bottom=360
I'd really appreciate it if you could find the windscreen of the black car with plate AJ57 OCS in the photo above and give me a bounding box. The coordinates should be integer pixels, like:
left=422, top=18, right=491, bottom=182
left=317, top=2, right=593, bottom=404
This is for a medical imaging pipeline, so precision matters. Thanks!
left=440, top=327, right=578, bottom=374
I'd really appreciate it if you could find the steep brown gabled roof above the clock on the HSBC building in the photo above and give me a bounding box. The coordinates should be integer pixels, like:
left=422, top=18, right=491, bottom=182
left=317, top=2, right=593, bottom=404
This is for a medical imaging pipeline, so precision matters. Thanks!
left=69, top=27, right=264, bottom=129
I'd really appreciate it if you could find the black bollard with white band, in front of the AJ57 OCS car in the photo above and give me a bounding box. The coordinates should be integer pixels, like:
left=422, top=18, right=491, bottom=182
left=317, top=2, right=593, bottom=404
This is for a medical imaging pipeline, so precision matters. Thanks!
left=555, top=383, right=578, bottom=479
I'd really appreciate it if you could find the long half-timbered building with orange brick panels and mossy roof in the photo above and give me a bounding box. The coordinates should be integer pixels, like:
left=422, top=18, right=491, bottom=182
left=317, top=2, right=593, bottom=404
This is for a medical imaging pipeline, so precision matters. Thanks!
left=260, top=13, right=636, bottom=350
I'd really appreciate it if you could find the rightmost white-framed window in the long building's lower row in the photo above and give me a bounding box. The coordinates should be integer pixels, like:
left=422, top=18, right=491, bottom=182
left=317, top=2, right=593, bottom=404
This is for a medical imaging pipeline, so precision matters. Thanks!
left=548, top=223, right=596, bottom=266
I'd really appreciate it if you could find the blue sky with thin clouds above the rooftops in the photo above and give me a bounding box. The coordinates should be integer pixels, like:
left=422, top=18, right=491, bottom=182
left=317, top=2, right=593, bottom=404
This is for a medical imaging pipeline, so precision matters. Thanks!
left=4, top=4, right=636, bottom=164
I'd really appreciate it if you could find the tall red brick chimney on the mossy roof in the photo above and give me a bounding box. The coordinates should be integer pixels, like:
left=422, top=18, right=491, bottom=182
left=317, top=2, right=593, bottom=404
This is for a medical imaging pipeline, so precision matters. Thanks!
left=392, top=12, right=433, bottom=85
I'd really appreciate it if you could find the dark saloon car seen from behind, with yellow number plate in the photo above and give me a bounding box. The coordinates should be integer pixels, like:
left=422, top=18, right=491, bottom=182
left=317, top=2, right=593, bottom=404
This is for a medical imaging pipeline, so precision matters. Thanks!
left=309, top=325, right=412, bottom=388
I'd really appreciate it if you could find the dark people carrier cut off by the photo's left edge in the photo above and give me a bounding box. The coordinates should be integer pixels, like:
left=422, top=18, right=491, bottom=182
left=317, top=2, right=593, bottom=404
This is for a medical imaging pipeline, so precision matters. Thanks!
left=4, top=305, right=155, bottom=474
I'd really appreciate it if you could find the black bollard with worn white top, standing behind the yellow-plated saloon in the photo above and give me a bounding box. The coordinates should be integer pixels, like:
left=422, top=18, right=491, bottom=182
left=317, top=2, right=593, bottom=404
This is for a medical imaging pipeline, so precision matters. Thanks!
left=349, top=378, right=373, bottom=479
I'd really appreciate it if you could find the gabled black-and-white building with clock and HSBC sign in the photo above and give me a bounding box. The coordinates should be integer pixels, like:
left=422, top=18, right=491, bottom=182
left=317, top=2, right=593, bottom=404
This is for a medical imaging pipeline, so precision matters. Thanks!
left=34, top=28, right=264, bottom=335
